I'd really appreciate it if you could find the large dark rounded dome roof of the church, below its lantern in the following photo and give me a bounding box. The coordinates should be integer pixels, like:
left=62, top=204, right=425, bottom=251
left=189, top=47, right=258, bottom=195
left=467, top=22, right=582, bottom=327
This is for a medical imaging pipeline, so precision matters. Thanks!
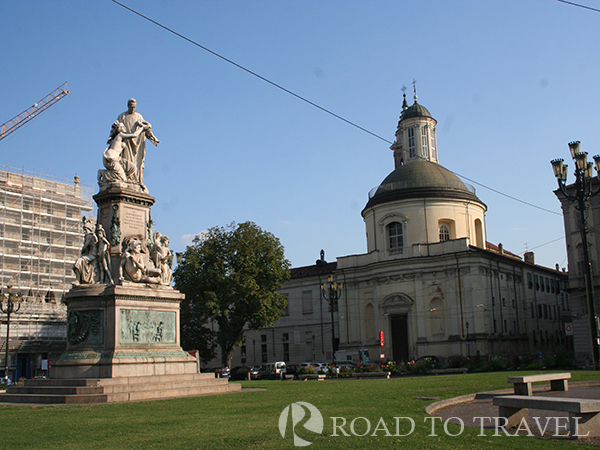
left=367, top=160, right=481, bottom=208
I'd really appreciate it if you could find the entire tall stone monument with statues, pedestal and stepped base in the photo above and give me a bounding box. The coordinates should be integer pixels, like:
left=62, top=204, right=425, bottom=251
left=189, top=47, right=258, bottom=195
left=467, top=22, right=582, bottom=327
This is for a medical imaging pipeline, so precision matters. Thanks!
left=0, top=99, right=240, bottom=403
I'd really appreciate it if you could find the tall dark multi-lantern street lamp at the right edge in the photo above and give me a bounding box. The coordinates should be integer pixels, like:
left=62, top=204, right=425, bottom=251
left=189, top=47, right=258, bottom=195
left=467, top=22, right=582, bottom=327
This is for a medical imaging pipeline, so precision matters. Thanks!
left=551, top=141, right=600, bottom=370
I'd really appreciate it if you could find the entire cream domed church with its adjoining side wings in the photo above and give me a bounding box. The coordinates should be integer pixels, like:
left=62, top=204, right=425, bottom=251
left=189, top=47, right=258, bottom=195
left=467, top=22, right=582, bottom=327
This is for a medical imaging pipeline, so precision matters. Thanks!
left=227, top=95, right=572, bottom=365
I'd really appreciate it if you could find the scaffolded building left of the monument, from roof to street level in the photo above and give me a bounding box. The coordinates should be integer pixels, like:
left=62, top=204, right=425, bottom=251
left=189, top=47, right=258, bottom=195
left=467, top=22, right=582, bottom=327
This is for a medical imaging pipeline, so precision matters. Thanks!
left=0, top=166, right=93, bottom=380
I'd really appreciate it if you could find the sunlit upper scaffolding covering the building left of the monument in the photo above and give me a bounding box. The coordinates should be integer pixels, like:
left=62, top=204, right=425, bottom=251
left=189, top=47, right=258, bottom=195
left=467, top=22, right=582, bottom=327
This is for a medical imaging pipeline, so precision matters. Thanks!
left=0, top=165, right=93, bottom=303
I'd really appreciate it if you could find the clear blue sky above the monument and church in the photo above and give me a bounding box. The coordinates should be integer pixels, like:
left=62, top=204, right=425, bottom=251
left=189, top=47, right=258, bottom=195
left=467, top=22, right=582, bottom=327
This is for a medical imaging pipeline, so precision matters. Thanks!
left=0, top=0, right=600, bottom=267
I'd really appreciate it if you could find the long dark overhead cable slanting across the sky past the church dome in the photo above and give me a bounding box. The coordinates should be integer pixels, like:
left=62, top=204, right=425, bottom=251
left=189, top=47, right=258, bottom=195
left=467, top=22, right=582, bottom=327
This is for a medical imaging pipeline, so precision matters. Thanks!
left=111, top=0, right=564, bottom=216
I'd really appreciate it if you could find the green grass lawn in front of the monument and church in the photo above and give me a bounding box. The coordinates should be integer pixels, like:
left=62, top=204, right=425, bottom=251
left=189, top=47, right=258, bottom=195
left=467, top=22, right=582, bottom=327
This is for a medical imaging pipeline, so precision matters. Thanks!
left=0, top=371, right=599, bottom=450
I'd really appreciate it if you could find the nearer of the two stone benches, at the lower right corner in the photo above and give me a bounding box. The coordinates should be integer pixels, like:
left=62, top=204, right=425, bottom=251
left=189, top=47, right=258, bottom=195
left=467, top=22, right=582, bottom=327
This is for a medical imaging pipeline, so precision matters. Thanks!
left=494, top=395, right=600, bottom=438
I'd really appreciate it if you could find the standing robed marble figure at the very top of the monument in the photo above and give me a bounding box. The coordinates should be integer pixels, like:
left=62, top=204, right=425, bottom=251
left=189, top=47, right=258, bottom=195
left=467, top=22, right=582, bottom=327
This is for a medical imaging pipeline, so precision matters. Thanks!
left=117, top=98, right=159, bottom=190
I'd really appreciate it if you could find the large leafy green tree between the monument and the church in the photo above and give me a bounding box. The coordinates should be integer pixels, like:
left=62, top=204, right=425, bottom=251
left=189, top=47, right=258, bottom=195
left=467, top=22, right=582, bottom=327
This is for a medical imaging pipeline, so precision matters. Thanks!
left=174, top=222, right=290, bottom=367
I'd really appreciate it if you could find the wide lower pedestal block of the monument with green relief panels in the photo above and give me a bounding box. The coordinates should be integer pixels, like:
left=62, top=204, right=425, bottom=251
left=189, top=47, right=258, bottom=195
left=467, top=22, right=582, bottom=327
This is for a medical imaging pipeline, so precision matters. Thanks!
left=50, top=282, right=197, bottom=379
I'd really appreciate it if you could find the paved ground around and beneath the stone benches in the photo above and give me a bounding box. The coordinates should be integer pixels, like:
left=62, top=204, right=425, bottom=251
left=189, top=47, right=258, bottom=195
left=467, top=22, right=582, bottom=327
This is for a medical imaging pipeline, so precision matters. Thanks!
left=433, top=381, right=600, bottom=446
